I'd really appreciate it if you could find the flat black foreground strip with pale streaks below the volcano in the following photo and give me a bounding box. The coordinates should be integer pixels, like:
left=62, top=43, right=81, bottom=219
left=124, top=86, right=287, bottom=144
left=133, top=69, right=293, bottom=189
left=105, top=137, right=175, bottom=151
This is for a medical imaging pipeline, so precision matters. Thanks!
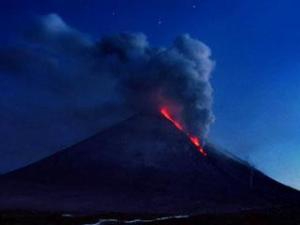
left=0, top=207, right=300, bottom=225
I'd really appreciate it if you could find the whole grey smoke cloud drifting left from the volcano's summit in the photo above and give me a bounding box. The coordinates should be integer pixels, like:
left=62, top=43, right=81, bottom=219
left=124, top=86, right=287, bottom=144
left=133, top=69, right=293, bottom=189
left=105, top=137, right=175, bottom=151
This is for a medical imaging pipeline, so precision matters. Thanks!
left=0, top=14, right=214, bottom=171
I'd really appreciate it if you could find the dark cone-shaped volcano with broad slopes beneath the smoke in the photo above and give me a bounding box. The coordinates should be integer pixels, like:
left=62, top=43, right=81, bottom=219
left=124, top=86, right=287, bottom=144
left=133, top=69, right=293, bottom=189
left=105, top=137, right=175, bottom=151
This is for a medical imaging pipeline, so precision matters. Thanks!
left=0, top=114, right=300, bottom=214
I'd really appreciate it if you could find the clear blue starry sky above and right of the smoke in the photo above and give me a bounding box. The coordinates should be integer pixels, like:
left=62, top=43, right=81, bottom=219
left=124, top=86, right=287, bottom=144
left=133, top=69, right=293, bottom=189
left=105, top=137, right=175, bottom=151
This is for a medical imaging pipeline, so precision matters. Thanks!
left=0, top=0, right=300, bottom=188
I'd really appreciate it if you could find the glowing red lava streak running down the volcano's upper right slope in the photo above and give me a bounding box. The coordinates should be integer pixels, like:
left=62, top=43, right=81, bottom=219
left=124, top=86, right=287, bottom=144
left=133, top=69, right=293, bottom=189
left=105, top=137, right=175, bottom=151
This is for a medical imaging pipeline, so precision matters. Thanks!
left=160, top=107, right=207, bottom=156
